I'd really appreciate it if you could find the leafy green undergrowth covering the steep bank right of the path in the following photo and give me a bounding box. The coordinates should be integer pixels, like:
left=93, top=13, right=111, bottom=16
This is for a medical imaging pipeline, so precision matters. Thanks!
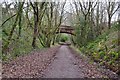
left=80, top=25, right=119, bottom=71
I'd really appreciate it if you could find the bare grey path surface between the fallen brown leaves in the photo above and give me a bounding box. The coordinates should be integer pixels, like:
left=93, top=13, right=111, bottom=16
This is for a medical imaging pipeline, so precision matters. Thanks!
left=43, top=46, right=84, bottom=78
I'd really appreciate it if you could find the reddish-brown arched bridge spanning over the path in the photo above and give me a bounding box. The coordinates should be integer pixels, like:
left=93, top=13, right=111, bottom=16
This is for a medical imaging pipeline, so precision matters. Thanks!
left=56, top=25, right=74, bottom=35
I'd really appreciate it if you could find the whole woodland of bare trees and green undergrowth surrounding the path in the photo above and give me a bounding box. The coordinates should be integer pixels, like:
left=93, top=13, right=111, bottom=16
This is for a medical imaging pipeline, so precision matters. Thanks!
left=0, top=0, right=120, bottom=74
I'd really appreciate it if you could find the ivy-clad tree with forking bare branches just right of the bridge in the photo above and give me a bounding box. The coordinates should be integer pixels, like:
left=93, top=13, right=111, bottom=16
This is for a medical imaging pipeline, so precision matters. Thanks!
left=74, top=1, right=97, bottom=45
